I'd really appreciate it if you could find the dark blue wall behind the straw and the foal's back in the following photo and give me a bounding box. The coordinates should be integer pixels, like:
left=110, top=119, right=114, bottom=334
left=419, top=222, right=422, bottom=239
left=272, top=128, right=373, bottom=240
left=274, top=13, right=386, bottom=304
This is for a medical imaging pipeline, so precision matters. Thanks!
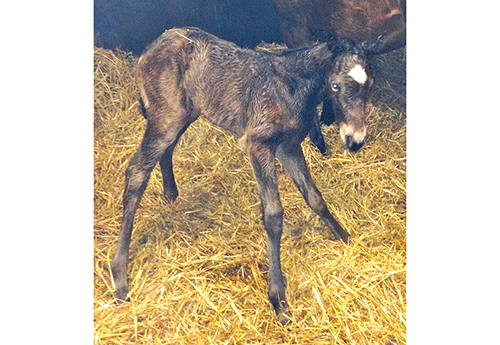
left=94, top=0, right=283, bottom=55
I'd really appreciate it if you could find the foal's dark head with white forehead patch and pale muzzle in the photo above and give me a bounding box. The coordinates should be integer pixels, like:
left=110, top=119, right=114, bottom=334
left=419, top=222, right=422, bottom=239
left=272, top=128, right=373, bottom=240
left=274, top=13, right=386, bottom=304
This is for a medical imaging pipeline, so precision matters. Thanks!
left=327, top=37, right=380, bottom=152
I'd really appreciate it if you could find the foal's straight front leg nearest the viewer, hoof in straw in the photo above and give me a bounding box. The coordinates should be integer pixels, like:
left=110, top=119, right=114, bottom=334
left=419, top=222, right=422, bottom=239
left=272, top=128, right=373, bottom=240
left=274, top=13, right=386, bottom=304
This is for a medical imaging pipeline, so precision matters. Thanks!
left=248, top=144, right=290, bottom=324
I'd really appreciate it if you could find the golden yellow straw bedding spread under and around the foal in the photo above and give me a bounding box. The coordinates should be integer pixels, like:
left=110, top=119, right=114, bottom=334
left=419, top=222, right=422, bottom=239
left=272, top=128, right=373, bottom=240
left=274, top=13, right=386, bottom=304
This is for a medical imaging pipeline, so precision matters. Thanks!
left=94, top=44, right=406, bottom=345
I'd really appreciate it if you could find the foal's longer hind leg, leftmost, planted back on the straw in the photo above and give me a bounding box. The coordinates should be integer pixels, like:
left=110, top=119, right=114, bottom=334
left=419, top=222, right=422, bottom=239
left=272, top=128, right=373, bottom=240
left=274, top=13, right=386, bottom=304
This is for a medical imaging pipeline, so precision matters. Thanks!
left=111, top=116, right=193, bottom=300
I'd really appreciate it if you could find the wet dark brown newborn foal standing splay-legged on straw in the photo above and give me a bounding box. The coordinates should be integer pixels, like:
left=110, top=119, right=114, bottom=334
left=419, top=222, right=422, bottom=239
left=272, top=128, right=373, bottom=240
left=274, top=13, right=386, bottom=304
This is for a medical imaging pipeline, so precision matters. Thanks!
left=112, top=28, right=376, bottom=323
